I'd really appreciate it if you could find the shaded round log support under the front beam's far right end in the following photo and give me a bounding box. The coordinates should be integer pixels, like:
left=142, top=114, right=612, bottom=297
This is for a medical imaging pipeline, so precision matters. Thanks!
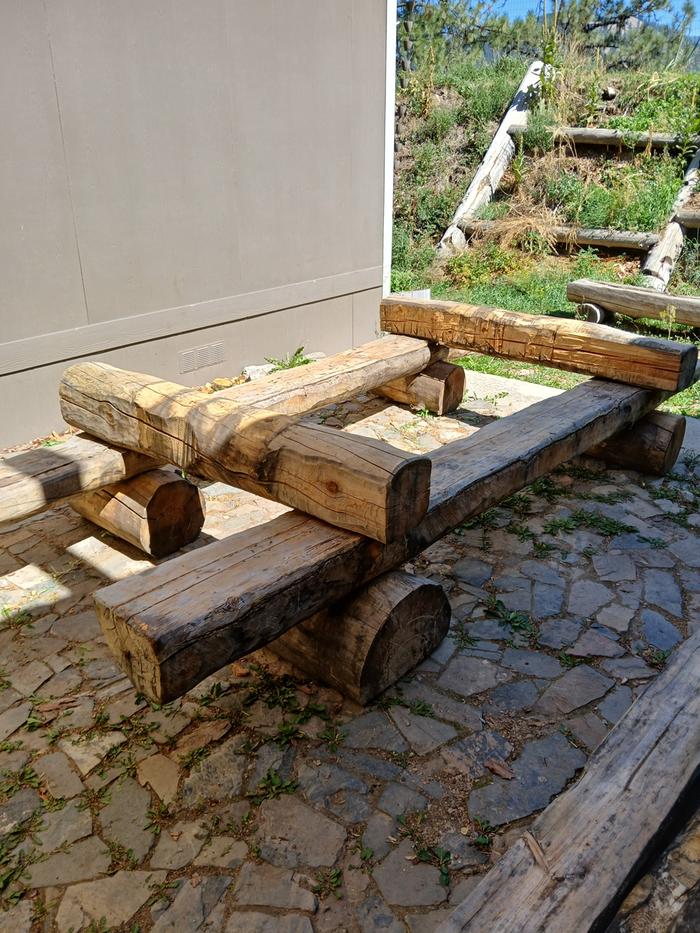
left=587, top=411, right=685, bottom=476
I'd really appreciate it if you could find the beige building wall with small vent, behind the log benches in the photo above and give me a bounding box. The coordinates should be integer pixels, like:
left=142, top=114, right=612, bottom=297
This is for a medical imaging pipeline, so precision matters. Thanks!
left=0, top=0, right=387, bottom=445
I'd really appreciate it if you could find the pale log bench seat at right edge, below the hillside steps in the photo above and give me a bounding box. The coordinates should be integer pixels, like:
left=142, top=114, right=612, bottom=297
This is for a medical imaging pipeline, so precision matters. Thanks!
left=566, top=279, right=700, bottom=326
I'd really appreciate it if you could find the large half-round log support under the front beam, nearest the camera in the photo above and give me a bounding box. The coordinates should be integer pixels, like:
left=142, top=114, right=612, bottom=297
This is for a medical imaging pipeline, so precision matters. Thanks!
left=269, top=571, right=451, bottom=706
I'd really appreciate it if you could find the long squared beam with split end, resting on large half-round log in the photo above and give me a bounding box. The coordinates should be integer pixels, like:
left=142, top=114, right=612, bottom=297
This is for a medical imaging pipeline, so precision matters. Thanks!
left=95, top=380, right=666, bottom=702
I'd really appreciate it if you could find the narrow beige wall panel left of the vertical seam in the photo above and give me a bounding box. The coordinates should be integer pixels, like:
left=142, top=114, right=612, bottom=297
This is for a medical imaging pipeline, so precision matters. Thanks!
left=0, top=0, right=87, bottom=343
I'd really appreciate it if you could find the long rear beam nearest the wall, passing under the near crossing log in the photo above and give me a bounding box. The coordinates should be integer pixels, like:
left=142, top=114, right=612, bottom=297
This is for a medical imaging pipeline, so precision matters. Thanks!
left=0, top=336, right=440, bottom=525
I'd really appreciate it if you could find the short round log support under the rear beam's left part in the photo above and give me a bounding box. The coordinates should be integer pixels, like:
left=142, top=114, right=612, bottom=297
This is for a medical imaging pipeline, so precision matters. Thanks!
left=70, top=470, right=204, bottom=557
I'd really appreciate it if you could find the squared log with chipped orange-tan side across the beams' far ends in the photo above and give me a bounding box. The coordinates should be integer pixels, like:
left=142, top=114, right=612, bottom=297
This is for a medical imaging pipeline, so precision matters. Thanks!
left=381, top=297, right=698, bottom=392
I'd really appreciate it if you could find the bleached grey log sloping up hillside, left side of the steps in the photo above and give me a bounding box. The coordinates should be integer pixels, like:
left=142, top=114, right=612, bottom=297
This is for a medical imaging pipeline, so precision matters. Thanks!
left=437, top=62, right=545, bottom=256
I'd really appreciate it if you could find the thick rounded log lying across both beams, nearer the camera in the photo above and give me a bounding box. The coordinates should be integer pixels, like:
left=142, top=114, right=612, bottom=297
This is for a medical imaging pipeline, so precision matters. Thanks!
left=59, top=363, right=430, bottom=541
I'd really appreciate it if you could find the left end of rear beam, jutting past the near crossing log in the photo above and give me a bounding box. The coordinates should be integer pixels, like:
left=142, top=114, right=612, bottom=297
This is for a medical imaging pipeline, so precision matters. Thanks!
left=0, top=434, right=158, bottom=525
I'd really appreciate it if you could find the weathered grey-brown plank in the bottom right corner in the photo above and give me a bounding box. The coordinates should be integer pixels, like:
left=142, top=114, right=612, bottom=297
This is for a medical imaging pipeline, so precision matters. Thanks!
left=437, top=633, right=700, bottom=933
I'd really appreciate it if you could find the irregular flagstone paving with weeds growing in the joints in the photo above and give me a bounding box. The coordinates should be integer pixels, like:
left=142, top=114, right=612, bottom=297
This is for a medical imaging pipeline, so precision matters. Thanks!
left=0, top=374, right=700, bottom=933
